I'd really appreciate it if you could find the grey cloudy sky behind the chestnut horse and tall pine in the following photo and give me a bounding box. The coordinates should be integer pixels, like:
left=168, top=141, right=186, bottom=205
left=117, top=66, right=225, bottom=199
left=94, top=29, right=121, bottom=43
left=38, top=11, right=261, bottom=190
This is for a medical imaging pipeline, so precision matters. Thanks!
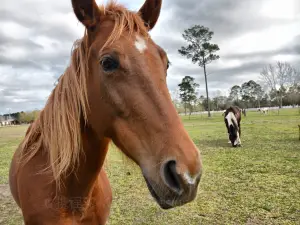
left=0, top=0, right=300, bottom=114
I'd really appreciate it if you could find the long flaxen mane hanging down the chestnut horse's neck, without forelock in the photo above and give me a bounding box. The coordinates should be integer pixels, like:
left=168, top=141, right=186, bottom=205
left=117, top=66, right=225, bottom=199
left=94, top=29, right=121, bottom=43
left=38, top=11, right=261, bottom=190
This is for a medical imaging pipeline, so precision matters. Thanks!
left=20, top=37, right=88, bottom=186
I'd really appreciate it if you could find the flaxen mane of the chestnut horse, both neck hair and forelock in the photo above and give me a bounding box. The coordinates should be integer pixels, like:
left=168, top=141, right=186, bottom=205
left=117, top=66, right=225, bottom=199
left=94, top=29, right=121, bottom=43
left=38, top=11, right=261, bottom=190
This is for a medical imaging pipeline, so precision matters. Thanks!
left=19, top=1, right=149, bottom=186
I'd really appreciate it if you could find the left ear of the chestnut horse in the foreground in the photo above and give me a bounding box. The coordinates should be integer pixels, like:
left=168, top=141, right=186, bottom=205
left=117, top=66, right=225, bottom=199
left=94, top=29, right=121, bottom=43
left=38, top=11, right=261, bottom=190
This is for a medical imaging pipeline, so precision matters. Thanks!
left=72, top=0, right=100, bottom=29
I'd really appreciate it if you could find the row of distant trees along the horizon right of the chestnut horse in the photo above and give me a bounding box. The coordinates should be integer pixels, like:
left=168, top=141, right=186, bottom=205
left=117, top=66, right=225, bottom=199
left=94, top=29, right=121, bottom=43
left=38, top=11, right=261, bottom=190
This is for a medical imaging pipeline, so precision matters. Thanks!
left=173, top=61, right=300, bottom=114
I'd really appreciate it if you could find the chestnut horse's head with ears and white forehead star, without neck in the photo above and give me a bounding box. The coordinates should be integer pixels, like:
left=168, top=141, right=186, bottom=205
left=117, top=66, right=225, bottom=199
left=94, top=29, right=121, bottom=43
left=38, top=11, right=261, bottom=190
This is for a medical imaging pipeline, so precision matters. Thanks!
left=72, top=0, right=202, bottom=209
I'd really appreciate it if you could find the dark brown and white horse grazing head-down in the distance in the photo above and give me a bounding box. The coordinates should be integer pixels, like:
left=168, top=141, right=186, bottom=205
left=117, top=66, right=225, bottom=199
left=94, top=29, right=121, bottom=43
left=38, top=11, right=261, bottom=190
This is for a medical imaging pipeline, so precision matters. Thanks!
left=224, top=106, right=242, bottom=147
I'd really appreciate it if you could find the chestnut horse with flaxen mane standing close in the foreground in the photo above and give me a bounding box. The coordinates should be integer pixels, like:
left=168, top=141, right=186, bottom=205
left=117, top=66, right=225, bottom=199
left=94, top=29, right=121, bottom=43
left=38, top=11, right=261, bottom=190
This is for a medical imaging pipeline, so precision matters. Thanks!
left=9, top=0, right=202, bottom=225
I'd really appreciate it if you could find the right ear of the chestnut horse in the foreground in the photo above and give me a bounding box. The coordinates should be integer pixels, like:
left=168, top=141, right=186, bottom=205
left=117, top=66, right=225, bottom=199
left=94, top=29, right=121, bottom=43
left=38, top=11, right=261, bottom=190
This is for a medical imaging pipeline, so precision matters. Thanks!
left=139, top=0, right=162, bottom=30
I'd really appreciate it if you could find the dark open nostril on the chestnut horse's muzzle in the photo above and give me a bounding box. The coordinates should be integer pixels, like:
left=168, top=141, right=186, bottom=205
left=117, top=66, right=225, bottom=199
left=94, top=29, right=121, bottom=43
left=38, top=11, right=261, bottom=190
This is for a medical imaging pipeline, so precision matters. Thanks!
left=163, top=160, right=182, bottom=194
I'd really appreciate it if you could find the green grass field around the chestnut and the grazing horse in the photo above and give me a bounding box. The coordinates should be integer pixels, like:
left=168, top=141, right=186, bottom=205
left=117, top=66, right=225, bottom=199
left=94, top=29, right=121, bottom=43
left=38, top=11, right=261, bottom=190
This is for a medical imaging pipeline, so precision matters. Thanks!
left=0, top=109, right=300, bottom=225
